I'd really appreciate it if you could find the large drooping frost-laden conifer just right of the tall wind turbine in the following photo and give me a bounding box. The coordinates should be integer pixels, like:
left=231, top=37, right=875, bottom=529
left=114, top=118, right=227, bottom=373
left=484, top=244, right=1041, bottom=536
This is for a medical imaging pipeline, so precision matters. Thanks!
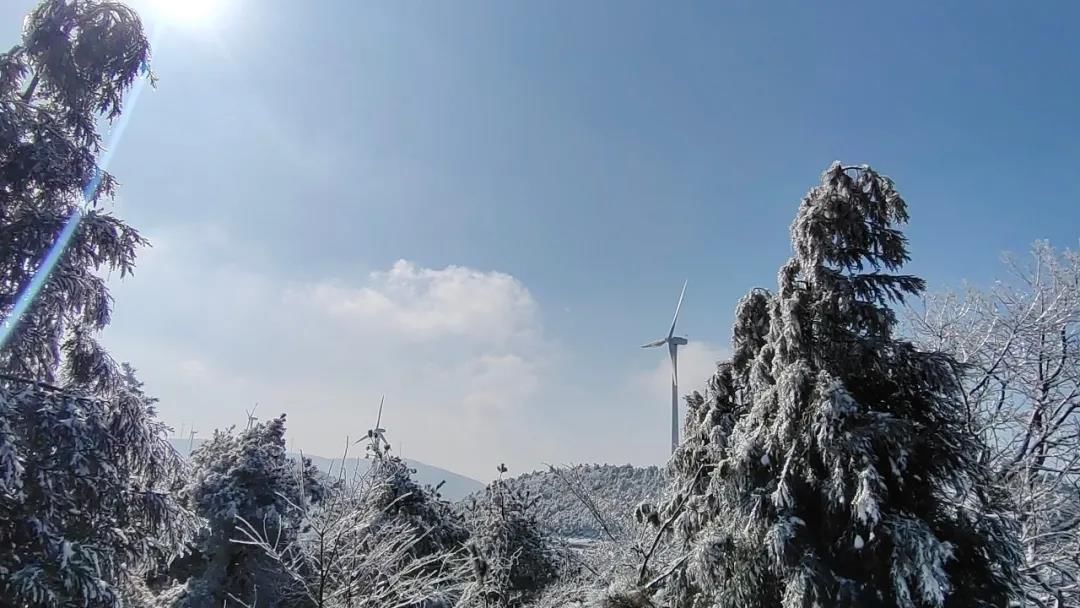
left=661, top=163, right=1017, bottom=608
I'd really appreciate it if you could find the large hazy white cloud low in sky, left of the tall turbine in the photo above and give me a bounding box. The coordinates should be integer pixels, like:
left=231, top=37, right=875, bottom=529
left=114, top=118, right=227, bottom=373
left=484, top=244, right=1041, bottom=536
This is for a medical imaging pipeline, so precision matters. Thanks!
left=106, top=223, right=555, bottom=477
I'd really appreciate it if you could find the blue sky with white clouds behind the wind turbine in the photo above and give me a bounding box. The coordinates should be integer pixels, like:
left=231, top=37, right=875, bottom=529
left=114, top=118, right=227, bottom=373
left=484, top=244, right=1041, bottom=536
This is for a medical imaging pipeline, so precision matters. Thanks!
left=0, top=0, right=1080, bottom=478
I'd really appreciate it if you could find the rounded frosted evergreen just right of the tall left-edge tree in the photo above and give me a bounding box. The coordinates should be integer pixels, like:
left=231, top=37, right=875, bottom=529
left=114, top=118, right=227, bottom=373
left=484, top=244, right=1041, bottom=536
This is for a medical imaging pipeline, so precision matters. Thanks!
left=172, top=415, right=325, bottom=608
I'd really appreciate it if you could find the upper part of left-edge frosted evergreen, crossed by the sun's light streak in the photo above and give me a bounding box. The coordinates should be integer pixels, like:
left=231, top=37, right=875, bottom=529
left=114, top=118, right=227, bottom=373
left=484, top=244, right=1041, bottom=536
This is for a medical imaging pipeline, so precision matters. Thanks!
left=0, top=0, right=150, bottom=390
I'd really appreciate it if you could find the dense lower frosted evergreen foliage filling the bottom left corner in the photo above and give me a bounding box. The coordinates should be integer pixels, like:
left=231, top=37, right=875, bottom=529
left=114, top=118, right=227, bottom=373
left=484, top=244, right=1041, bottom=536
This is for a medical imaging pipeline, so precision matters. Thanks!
left=0, top=366, right=194, bottom=608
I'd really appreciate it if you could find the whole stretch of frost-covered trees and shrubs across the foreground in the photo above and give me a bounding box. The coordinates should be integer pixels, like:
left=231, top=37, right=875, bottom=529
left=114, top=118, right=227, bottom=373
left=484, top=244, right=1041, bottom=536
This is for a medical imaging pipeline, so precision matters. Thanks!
left=0, top=0, right=1080, bottom=608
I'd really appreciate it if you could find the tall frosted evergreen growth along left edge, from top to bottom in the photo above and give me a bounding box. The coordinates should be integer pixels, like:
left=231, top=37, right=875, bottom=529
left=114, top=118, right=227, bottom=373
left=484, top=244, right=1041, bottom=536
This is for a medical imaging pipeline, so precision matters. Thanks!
left=0, top=0, right=198, bottom=607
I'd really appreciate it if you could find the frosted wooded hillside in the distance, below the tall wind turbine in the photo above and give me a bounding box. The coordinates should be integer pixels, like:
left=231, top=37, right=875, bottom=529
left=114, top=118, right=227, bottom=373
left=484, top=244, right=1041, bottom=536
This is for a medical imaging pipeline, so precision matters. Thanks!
left=468, top=464, right=666, bottom=539
